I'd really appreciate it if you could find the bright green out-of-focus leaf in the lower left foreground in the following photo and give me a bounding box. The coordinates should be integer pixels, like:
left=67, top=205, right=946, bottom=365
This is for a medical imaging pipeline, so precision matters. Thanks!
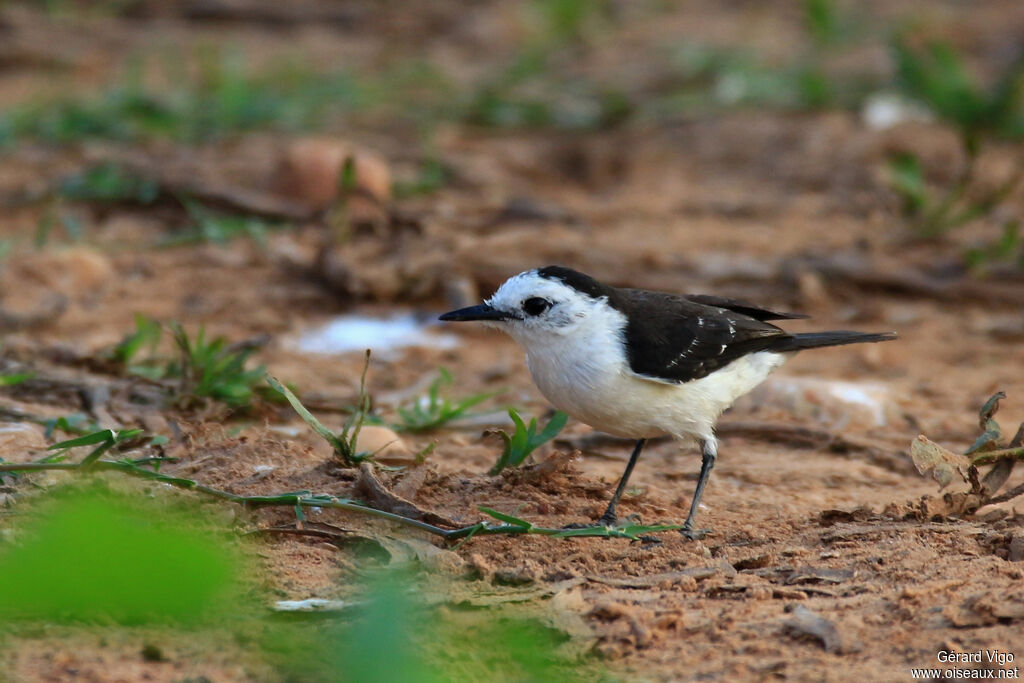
left=0, top=489, right=239, bottom=624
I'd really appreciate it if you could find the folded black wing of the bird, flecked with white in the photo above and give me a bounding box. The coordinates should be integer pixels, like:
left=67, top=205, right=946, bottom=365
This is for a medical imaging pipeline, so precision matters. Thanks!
left=616, top=290, right=790, bottom=384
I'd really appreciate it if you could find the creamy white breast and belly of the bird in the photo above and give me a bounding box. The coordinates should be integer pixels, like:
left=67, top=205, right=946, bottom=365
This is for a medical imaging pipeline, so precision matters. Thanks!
left=526, top=351, right=786, bottom=439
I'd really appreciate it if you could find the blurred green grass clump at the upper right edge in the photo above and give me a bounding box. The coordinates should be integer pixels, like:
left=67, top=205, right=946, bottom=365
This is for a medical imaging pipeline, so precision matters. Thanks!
left=889, top=37, right=1024, bottom=248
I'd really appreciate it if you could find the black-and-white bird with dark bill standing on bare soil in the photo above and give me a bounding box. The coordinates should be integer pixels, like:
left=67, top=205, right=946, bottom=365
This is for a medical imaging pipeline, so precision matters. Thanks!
left=440, top=265, right=897, bottom=540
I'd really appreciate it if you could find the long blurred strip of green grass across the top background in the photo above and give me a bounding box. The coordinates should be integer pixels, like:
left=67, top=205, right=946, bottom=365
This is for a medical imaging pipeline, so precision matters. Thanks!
left=0, top=0, right=877, bottom=143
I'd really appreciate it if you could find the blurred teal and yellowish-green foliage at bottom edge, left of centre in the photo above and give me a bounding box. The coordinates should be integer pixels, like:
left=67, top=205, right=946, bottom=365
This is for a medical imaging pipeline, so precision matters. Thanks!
left=261, top=570, right=594, bottom=683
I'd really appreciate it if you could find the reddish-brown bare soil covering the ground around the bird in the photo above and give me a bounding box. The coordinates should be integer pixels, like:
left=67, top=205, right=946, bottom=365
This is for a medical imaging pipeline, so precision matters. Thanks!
left=0, top=1, right=1024, bottom=681
